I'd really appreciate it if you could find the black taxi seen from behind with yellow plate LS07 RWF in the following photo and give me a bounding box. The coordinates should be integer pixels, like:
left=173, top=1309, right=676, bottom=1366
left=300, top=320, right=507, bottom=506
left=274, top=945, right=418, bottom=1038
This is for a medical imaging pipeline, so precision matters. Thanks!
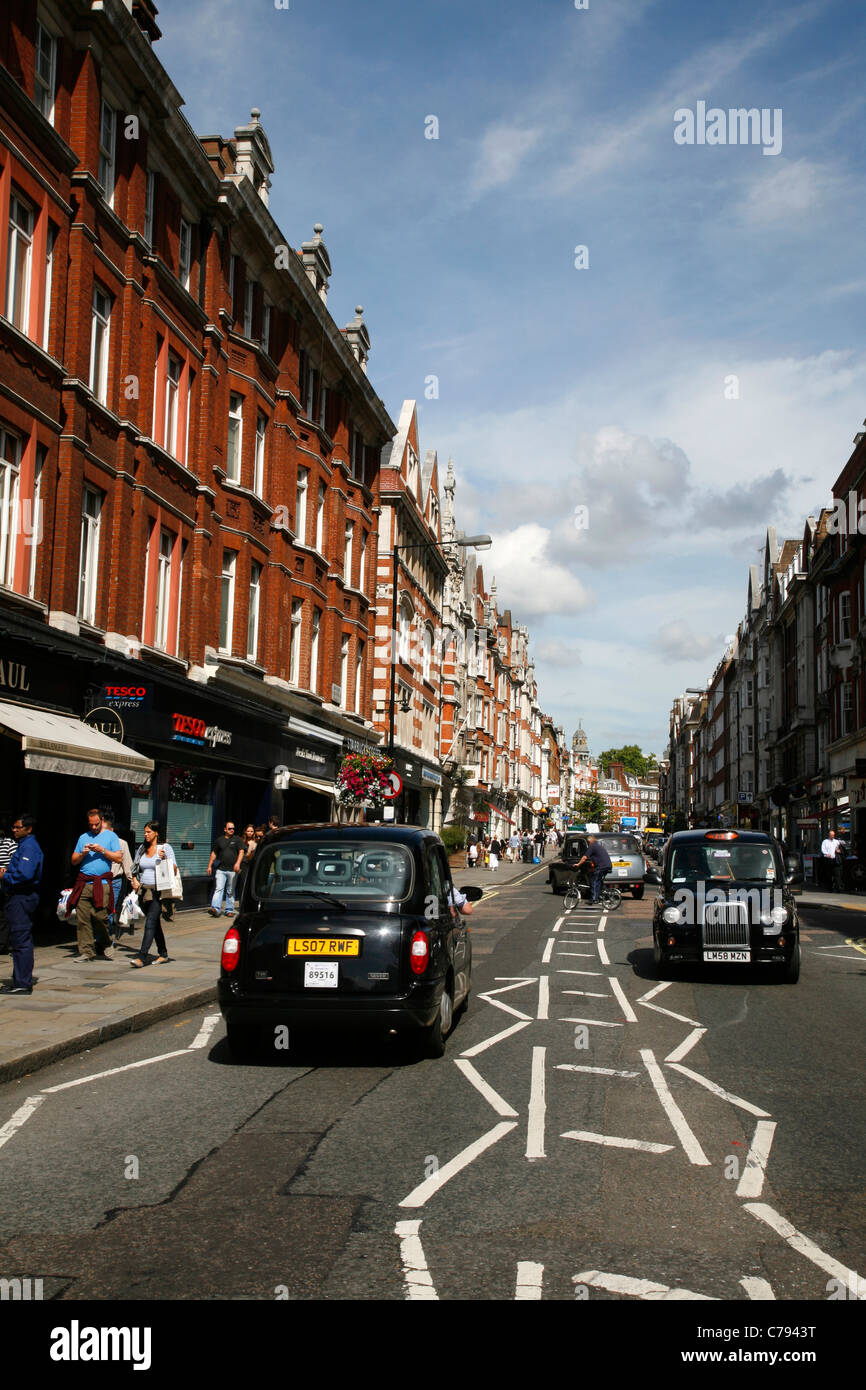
left=218, top=824, right=482, bottom=1056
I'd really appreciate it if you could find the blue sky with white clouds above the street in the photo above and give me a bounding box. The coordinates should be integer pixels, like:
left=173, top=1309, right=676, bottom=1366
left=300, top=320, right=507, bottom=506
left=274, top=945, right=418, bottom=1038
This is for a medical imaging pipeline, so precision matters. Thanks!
left=157, top=0, right=866, bottom=753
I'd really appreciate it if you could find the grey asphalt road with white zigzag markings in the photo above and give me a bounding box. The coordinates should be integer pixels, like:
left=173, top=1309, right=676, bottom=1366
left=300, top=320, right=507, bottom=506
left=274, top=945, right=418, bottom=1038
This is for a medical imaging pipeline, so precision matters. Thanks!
left=0, top=865, right=866, bottom=1302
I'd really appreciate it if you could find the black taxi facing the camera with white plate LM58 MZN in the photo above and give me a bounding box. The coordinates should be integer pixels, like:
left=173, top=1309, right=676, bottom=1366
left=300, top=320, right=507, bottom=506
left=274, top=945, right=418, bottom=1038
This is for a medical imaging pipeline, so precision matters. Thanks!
left=652, top=830, right=801, bottom=984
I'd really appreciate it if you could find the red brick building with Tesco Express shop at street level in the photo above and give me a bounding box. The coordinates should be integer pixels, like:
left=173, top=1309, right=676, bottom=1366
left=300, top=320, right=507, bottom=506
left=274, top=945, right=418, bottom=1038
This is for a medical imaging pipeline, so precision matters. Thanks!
left=0, top=0, right=395, bottom=906
